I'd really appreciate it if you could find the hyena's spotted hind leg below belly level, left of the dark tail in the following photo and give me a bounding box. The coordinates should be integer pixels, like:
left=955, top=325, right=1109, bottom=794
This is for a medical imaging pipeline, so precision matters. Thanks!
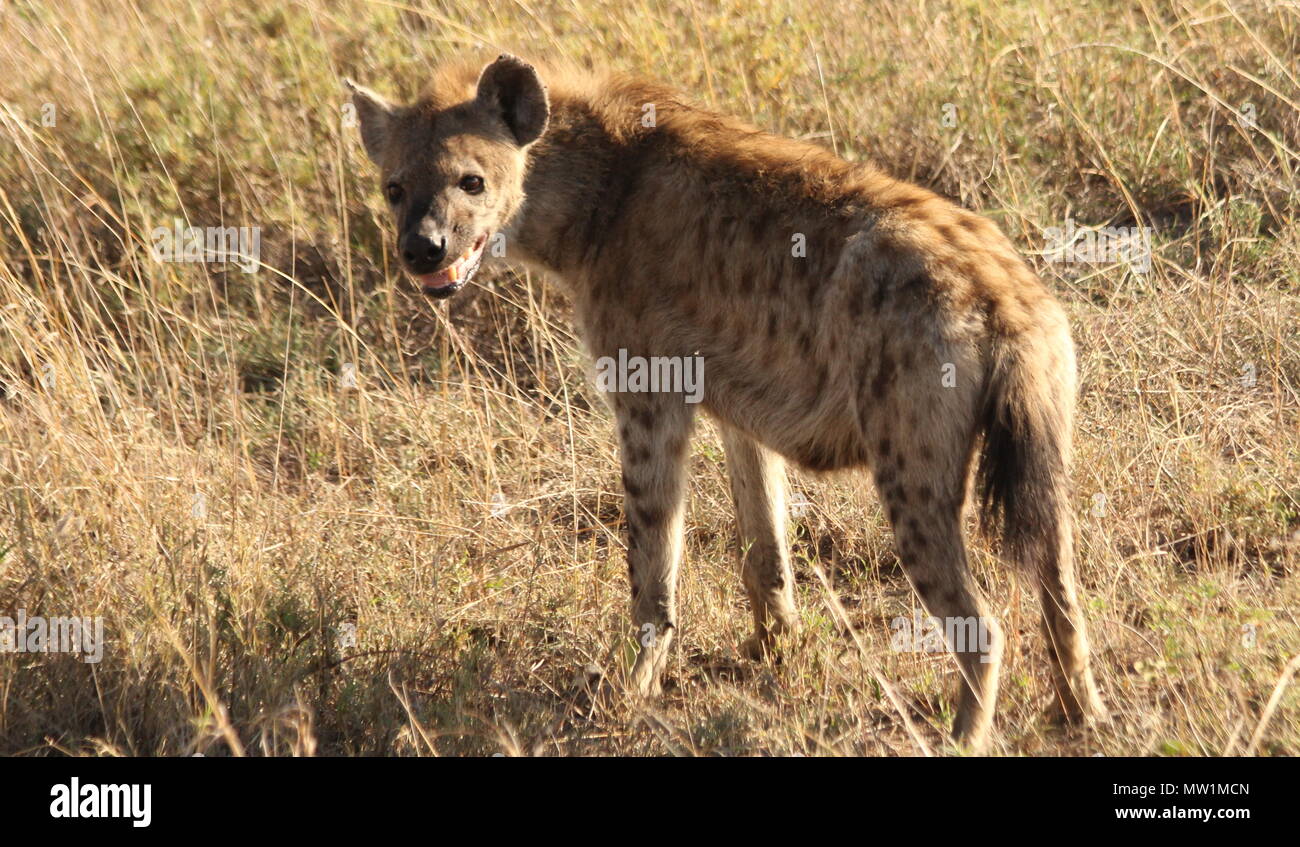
left=876, top=469, right=1004, bottom=752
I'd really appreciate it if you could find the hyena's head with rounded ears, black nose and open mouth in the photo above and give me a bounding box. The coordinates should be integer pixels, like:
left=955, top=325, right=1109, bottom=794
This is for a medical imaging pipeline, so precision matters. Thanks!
left=347, top=55, right=550, bottom=299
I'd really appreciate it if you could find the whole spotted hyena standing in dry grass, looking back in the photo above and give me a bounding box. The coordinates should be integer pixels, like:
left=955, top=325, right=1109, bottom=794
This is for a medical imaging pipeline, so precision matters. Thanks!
left=348, top=56, right=1104, bottom=748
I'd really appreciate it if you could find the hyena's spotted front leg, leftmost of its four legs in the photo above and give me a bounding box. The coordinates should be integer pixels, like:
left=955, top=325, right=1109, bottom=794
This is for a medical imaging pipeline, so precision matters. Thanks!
left=615, top=394, right=694, bottom=696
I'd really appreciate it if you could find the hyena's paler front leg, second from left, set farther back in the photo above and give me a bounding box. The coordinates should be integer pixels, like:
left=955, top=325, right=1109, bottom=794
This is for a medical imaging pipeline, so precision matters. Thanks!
left=723, top=426, right=798, bottom=659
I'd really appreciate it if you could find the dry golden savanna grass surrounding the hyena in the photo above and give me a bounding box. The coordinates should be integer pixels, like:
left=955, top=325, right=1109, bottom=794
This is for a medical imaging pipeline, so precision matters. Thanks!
left=0, top=0, right=1300, bottom=755
